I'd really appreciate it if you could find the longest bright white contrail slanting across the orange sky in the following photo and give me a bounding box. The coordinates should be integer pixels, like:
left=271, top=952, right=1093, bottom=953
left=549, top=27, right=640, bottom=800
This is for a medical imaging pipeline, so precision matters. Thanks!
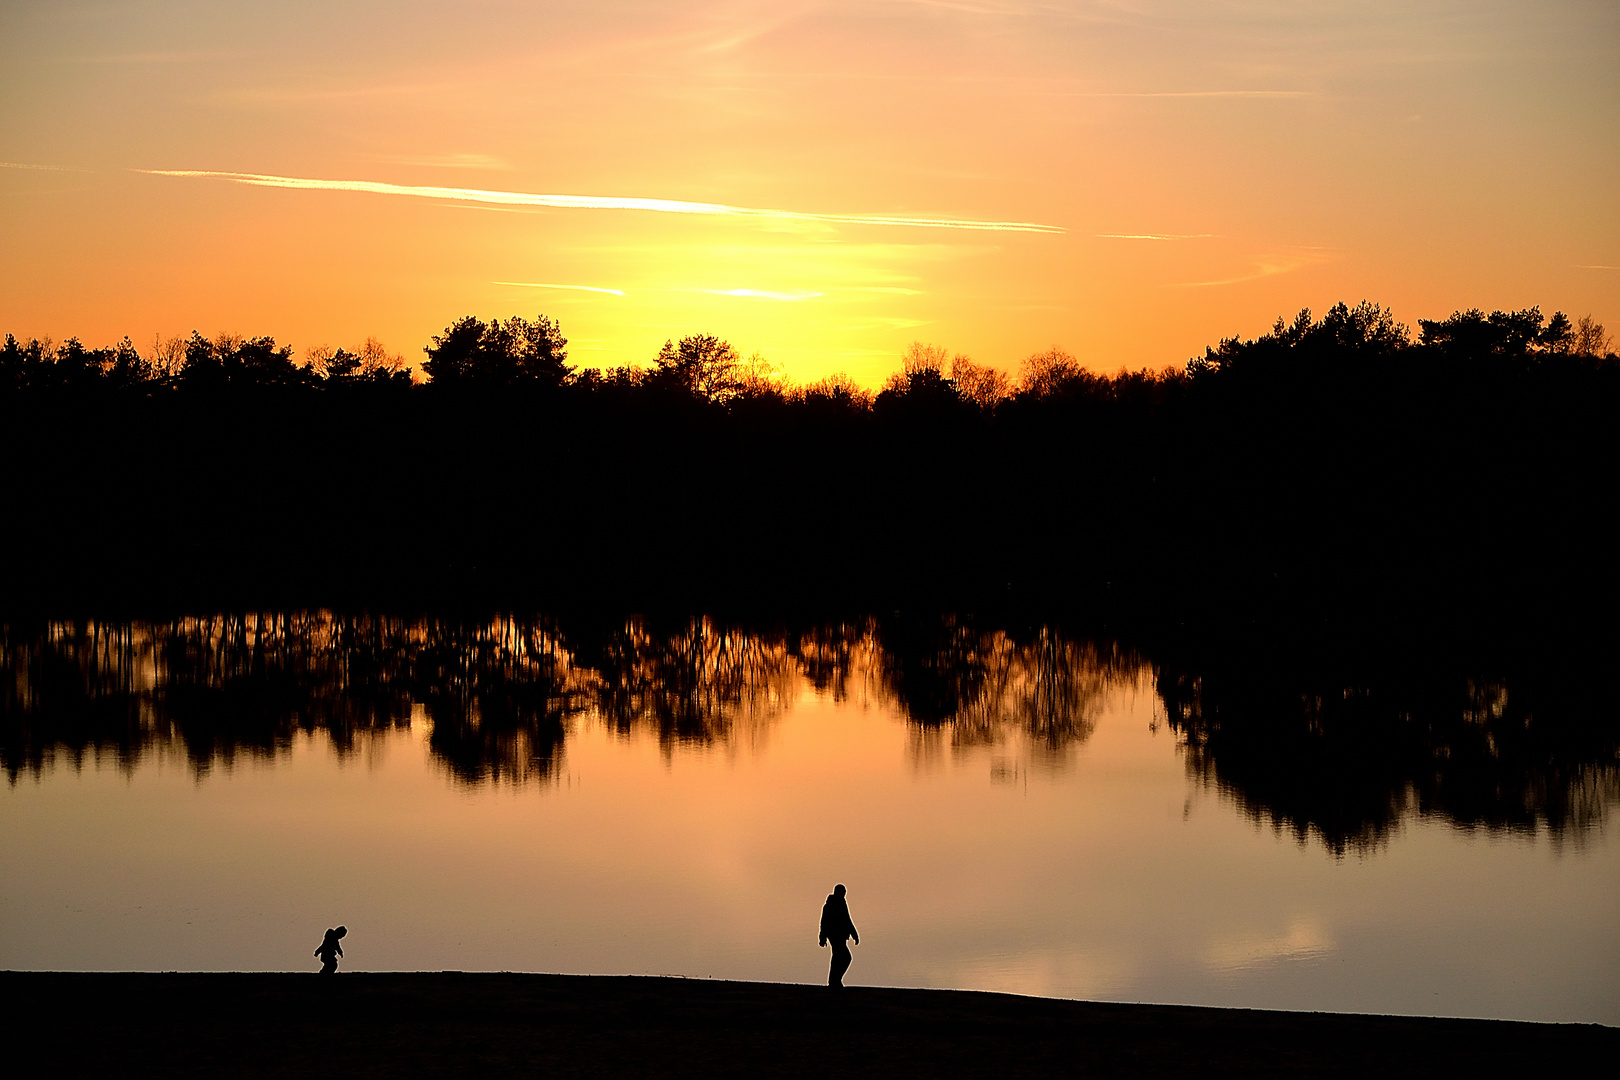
left=134, top=168, right=1066, bottom=233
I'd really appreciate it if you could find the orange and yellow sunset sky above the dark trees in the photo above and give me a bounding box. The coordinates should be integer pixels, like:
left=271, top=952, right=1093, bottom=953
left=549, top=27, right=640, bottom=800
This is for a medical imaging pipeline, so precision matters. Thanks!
left=0, top=0, right=1620, bottom=382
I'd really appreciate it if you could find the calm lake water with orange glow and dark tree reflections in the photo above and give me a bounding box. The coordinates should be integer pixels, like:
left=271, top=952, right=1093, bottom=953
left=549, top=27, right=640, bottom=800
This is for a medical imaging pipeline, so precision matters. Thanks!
left=0, top=614, right=1620, bottom=1023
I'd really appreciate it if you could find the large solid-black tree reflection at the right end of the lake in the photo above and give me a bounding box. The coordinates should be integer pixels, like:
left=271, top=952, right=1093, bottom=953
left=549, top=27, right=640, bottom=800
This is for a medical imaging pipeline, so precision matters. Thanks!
left=1157, top=650, right=1620, bottom=853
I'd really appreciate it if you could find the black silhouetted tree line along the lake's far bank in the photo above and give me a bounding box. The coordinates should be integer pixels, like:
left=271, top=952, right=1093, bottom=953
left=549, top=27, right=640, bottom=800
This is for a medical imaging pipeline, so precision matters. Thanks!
left=0, top=303, right=1620, bottom=648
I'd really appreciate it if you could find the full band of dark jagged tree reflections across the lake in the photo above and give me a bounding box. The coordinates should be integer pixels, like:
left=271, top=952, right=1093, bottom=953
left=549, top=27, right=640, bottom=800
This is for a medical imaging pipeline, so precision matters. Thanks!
left=0, top=612, right=1620, bottom=853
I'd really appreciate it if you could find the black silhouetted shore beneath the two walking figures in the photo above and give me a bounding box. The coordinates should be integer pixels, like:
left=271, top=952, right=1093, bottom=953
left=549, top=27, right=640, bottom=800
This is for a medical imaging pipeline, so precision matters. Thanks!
left=9, top=972, right=1620, bottom=1078
